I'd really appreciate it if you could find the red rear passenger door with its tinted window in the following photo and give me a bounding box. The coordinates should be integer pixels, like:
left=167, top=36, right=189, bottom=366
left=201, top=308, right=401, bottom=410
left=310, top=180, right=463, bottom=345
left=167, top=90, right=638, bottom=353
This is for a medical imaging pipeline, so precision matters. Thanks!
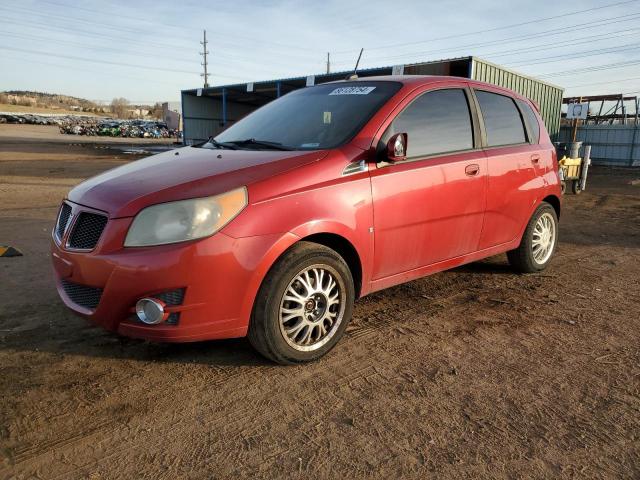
left=474, top=87, right=543, bottom=250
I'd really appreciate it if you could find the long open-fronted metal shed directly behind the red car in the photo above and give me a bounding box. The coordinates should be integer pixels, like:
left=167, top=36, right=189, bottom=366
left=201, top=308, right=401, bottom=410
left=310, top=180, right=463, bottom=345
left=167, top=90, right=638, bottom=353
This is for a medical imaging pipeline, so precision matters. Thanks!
left=182, top=57, right=563, bottom=145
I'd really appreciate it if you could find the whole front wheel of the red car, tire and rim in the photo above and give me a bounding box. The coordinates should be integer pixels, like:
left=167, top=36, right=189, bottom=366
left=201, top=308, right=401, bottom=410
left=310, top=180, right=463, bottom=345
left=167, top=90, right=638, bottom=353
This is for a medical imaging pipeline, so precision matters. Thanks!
left=248, top=242, right=355, bottom=365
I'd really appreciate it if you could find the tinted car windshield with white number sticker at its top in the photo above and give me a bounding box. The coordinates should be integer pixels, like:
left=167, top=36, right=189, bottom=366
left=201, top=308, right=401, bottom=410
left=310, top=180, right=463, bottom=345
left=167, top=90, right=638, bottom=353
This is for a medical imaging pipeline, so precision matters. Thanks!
left=201, top=81, right=402, bottom=150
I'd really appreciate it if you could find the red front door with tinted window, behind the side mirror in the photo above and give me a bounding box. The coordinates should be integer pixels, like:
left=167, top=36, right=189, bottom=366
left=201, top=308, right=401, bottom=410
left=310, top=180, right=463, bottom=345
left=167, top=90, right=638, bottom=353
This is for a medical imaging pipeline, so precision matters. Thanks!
left=371, top=84, right=487, bottom=279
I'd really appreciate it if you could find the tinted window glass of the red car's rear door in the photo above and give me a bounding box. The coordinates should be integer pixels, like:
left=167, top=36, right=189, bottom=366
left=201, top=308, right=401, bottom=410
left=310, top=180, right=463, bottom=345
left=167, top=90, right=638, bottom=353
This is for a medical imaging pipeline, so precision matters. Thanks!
left=476, top=90, right=527, bottom=147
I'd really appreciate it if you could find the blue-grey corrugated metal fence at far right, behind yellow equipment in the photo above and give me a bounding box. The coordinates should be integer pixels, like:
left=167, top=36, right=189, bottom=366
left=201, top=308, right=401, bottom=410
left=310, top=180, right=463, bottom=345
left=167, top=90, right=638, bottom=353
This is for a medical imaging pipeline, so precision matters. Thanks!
left=558, top=125, right=640, bottom=167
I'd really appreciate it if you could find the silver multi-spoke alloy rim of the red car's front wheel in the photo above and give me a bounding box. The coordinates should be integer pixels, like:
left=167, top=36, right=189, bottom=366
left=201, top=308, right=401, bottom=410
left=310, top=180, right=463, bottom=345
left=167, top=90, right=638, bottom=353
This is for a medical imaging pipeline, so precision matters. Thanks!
left=279, top=265, right=346, bottom=351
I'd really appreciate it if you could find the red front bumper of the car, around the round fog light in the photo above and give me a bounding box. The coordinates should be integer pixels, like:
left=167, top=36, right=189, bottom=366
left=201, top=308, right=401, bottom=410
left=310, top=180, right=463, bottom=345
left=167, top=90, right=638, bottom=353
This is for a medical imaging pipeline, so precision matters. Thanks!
left=51, top=214, right=294, bottom=342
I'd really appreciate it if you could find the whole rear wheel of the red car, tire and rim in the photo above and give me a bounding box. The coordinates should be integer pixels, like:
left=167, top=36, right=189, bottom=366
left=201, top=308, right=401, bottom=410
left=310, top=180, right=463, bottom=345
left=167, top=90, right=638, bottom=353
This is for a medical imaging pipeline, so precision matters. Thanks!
left=507, top=202, right=558, bottom=273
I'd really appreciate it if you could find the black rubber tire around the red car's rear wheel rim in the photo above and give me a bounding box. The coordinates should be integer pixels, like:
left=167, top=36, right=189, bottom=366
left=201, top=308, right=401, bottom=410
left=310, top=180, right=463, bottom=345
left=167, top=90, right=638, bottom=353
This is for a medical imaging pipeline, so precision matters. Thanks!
left=507, top=202, right=558, bottom=273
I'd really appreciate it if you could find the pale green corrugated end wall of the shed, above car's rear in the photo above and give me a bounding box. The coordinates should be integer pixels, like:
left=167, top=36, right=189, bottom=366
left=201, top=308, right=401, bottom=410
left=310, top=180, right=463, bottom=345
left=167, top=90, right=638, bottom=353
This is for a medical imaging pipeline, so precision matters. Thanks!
left=471, top=57, right=564, bottom=141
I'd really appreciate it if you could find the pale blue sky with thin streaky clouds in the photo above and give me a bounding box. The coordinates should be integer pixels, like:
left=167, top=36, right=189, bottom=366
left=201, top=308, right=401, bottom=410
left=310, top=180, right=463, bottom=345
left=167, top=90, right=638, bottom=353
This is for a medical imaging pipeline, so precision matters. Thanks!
left=0, top=0, right=640, bottom=103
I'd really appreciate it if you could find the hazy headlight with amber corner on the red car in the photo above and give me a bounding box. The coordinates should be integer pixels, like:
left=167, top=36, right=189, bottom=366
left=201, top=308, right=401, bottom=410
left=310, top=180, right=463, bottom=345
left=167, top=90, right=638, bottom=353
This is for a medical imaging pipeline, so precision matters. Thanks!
left=124, top=187, right=247, bottom=247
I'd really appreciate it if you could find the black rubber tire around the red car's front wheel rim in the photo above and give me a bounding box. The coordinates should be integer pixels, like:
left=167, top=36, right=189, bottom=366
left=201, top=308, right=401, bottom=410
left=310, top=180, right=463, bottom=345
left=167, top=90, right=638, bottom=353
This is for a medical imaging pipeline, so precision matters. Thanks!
left=248, top=241, right=355, bottom=365
